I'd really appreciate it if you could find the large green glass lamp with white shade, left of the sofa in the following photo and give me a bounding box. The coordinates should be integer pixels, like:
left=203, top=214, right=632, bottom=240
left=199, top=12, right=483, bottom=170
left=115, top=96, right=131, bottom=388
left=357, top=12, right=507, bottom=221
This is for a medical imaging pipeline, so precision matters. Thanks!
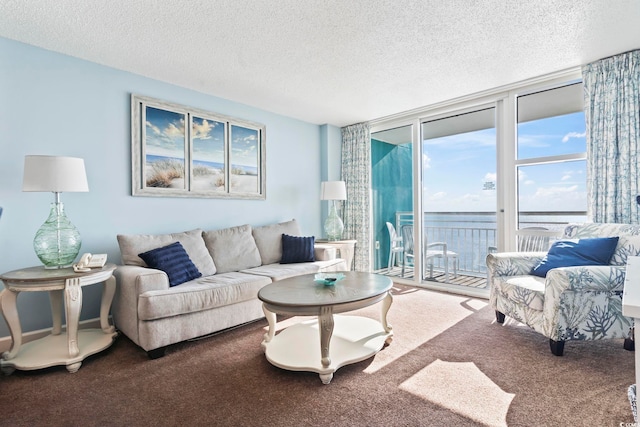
left=22, top=156, right=89, bottom=268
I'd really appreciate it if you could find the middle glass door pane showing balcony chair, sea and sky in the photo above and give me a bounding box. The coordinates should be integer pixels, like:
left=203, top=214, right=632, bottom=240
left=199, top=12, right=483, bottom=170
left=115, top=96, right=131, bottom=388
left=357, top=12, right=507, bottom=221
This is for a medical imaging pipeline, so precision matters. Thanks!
left=421, top=106, right=498, bottom=288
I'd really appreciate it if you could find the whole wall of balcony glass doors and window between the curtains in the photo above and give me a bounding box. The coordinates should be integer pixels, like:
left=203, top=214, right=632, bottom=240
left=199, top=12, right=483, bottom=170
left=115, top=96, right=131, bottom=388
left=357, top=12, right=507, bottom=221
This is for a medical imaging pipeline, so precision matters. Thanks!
left=371, top=70, right=586, bottom=296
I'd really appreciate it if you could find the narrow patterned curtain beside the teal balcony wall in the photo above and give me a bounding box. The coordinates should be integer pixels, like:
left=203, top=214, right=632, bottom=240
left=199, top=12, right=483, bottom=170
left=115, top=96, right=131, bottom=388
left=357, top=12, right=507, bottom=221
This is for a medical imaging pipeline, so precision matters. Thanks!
left=342, top=123, right=371, bottom=271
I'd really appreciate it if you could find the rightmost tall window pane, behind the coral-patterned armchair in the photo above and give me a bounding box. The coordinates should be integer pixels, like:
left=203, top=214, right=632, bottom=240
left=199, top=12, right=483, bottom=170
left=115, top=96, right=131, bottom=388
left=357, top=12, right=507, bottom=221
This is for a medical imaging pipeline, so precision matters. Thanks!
left=515, top=83, right=587, bottom=249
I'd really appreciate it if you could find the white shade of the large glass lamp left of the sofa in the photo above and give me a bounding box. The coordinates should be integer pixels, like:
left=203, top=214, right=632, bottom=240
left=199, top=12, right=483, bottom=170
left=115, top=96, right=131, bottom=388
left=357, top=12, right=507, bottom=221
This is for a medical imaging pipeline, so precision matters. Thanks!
left=22, top=156, right=89, bottom=193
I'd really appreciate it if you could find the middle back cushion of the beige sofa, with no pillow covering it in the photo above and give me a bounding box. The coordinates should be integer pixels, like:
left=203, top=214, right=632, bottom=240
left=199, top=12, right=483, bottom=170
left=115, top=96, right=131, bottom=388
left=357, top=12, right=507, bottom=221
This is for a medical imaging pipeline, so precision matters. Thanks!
left=203, top=225, right=262, bottom=273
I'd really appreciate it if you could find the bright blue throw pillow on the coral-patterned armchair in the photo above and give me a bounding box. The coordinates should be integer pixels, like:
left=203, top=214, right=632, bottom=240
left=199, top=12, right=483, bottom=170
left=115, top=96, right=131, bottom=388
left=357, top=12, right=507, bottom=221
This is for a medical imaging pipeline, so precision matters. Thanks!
left=531, top=237, right=618, bottom=277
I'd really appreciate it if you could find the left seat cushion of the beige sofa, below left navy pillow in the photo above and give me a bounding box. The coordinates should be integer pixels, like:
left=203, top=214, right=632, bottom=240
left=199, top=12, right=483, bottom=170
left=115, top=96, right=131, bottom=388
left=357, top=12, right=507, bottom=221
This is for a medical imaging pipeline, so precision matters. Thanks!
left=138, top=272, right=271, bottom=320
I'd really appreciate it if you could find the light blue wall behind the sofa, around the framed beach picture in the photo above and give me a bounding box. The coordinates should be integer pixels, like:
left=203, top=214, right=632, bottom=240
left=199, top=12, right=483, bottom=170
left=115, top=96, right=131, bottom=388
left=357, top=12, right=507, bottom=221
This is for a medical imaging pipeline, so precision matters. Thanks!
left=0, top=38, right=339, bottom=337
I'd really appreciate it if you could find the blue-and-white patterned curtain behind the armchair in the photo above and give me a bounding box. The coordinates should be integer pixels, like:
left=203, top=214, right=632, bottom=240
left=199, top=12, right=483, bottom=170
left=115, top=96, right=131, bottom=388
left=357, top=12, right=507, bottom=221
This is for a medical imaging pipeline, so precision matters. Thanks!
left=582, top=50, right=640, bottom=224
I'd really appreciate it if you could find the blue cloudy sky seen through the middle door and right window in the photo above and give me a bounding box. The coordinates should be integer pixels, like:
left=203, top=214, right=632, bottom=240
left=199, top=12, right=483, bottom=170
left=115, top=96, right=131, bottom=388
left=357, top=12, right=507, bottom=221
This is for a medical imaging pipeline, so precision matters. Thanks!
left=422, top=112, right=587, bottom=212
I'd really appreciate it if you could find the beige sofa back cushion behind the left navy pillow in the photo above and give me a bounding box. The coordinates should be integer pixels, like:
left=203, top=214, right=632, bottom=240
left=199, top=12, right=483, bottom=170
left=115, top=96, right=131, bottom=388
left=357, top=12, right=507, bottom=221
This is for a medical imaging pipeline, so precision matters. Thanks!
left=117, top=228, right=216, bottom=276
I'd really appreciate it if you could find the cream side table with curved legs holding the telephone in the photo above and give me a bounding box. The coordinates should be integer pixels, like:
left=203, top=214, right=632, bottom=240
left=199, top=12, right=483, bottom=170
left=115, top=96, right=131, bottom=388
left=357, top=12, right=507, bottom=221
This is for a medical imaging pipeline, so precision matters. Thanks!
left=0, top=264, right=118, bottom=375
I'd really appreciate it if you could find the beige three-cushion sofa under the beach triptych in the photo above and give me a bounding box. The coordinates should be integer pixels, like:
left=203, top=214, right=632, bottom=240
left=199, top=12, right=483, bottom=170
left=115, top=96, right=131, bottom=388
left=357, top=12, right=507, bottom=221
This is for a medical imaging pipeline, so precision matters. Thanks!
left=112, top=220, right=347, bottom=358
